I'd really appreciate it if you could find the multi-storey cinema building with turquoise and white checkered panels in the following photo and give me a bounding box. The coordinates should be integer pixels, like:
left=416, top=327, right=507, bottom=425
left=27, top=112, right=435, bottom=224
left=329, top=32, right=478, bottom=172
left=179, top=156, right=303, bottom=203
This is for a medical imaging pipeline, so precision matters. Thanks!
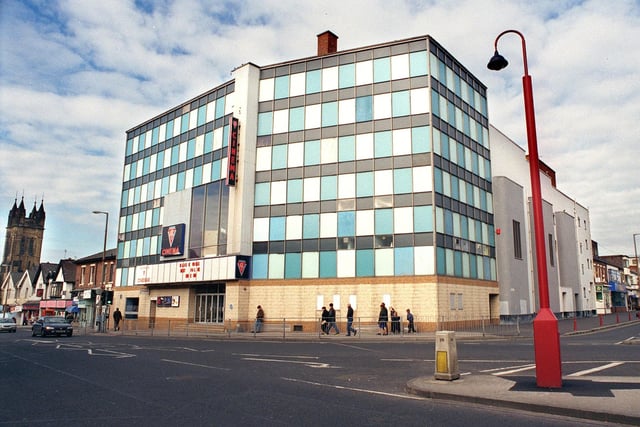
left=115, top=32, right=499, bottom=332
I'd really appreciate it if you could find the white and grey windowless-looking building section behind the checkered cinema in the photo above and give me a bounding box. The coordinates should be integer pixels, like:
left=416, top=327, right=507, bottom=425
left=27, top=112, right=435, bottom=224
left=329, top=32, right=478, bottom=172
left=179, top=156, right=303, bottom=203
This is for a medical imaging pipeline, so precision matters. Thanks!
left=489, top=126, right=595, bottom=319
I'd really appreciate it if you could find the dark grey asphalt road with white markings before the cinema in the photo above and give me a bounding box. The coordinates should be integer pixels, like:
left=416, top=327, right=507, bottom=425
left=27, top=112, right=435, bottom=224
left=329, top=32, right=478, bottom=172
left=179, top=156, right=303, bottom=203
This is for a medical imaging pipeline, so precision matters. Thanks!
left=0, top=323, right=640, bottom=426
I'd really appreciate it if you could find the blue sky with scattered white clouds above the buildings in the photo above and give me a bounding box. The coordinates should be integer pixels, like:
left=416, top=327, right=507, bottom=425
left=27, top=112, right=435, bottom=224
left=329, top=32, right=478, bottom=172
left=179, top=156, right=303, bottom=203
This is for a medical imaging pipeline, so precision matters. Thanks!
left=0, top=0, right=640, bottom=262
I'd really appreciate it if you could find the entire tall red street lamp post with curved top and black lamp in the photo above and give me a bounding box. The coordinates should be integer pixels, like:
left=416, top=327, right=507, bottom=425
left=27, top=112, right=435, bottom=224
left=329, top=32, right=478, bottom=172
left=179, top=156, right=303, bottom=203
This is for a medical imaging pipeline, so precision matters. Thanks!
left=487, top=30, right=562, bottom=388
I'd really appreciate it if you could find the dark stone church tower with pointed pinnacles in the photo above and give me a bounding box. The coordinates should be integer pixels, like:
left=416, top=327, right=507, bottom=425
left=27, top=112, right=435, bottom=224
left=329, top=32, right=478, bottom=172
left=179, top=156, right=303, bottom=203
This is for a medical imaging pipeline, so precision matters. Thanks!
left=0, top=198, right=46, bottom=277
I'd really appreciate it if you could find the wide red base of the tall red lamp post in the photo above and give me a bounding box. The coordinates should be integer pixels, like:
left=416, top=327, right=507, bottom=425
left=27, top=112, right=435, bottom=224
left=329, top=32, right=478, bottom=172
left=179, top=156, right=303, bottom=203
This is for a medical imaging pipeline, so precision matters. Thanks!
left=533, top=308, right=562, bottom=388
